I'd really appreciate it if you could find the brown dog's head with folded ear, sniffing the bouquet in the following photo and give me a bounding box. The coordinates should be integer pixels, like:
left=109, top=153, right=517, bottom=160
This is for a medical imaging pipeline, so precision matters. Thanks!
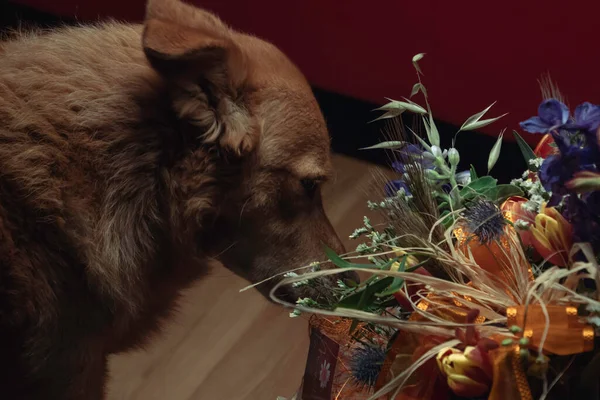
left=143, top=0, right=356, bottom=297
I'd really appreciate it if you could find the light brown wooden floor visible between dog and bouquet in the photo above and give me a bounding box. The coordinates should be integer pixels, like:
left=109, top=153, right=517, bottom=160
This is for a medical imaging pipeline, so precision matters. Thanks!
left=108, top=156, right=392, bottom=400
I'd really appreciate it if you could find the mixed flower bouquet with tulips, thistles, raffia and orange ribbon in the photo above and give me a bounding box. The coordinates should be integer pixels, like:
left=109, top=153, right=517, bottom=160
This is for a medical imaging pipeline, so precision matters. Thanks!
left=272, top=54, right=600, bottom=400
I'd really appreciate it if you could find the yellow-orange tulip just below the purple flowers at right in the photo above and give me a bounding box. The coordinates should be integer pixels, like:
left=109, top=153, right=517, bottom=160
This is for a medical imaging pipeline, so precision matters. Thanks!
left=530, top=204, right=573, bottom=267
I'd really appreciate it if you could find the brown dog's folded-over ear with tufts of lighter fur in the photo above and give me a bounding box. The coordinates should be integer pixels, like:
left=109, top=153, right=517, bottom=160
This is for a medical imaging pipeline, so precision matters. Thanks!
left=142, top=0, right=258, bottom=155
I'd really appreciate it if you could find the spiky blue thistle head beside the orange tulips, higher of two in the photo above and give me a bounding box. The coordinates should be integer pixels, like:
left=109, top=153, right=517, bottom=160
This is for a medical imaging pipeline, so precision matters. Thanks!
left=462, top=200, right=506, bottom=244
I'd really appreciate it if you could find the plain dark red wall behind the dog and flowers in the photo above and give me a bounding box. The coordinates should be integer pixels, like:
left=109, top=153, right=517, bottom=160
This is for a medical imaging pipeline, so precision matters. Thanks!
left=18, top=0, right=600, bottom=143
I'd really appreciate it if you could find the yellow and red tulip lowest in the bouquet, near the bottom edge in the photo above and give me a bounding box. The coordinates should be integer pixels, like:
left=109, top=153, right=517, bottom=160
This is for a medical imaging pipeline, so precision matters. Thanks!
left=436, top=346, right=492, bottom=398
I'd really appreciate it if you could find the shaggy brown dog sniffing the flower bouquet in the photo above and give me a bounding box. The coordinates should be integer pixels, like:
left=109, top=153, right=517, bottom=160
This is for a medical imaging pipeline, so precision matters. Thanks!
left=0, top=0, right=356, bottom=400
